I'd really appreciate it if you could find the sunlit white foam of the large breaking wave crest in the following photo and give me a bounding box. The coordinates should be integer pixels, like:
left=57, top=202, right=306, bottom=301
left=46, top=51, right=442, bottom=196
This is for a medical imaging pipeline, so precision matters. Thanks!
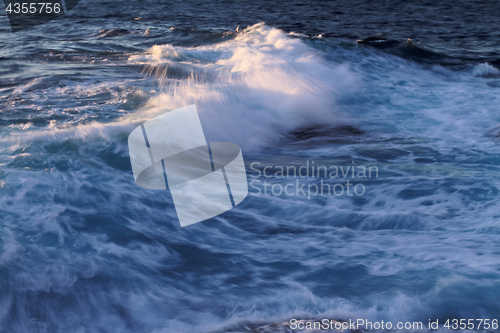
left=126, top=23, right=359, bottom=149
